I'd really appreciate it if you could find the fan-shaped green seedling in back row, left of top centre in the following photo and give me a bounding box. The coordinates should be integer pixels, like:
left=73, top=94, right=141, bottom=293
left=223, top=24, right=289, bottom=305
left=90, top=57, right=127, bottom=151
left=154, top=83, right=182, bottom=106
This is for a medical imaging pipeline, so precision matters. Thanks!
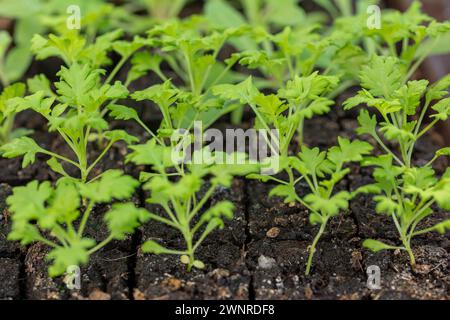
left=147, top=16, right=247, bottom=96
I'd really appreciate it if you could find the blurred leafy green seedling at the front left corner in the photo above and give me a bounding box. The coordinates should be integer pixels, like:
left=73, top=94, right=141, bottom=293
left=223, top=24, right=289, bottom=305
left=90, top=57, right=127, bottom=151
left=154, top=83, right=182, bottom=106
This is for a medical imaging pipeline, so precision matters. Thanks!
left=7, top=170, right=149, bottom=277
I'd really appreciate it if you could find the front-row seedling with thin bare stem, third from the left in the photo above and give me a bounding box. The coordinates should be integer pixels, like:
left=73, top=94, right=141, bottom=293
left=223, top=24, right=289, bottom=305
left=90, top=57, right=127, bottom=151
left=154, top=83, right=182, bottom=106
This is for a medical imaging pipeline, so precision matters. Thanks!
left=248, top=137, right=372, bottom=275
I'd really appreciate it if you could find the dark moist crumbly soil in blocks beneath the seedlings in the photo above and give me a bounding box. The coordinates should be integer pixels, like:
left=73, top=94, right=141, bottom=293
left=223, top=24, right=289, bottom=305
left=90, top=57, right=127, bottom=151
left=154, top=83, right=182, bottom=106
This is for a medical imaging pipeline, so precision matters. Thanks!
left=0, top=107, right=450, bottom=300
